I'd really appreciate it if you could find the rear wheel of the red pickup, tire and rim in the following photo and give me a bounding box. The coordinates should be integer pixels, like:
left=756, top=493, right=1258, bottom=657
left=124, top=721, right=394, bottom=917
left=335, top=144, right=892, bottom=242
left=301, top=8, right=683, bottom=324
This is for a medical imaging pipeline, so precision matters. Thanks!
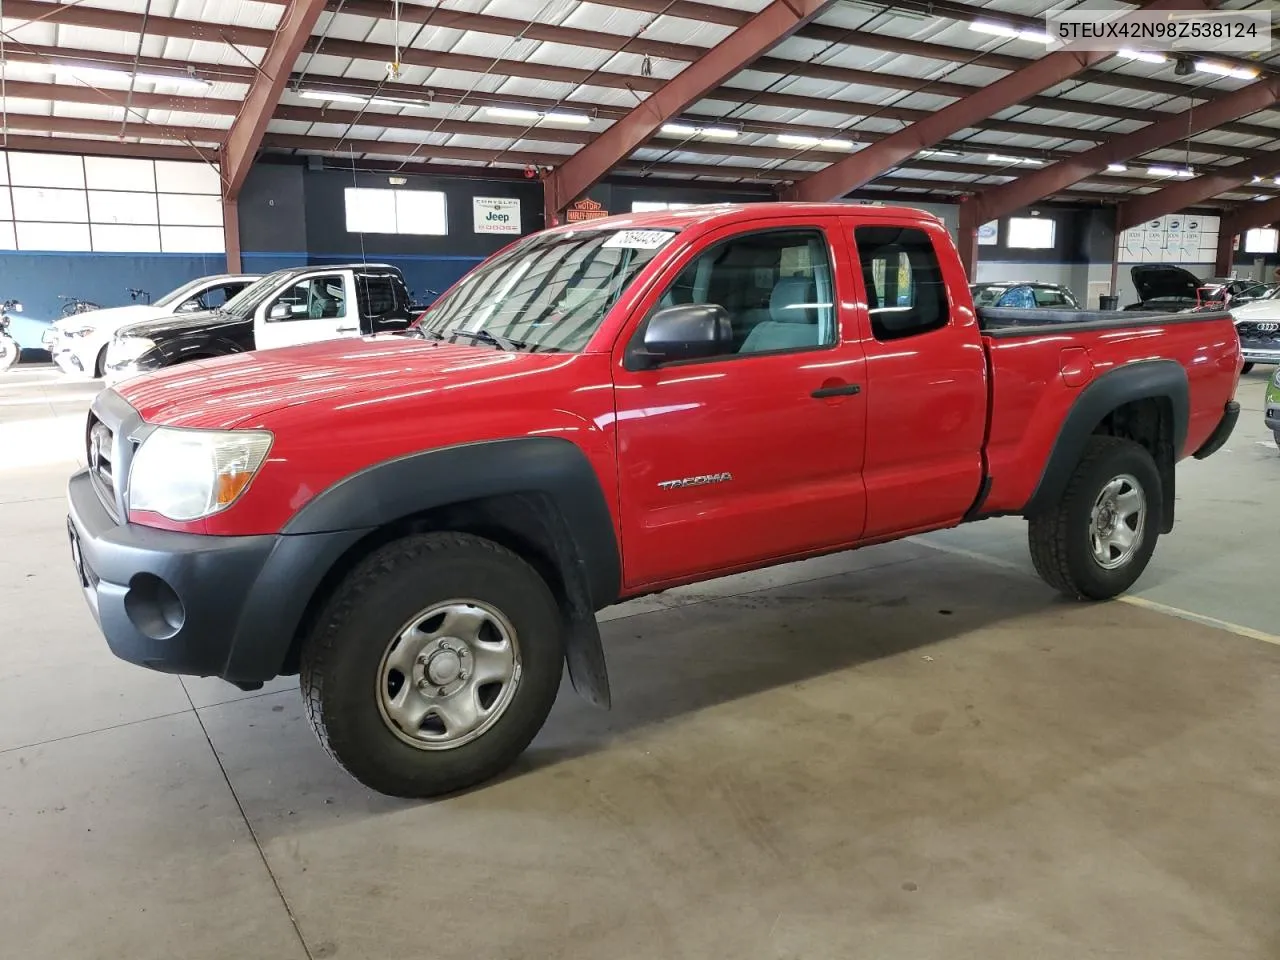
left=1028, top=436, right=1161, bottom=600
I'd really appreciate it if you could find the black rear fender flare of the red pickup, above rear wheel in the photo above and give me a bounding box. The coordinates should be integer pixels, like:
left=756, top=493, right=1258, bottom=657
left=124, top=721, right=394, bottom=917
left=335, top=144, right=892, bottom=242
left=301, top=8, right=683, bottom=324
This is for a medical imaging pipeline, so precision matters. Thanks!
left=1023, top=360, right=1190, bottom=532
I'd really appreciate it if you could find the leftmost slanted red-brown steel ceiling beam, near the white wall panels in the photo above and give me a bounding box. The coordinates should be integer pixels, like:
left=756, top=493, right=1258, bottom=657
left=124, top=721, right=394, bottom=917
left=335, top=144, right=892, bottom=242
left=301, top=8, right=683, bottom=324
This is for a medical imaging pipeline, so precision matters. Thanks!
left=222, top=0, right=324, bottom=199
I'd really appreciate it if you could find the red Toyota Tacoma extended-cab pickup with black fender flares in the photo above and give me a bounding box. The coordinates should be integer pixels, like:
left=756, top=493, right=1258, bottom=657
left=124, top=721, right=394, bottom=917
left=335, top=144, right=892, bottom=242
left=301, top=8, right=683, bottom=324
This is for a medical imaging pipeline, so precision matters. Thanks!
left=68, top=204, right=1242, bottom=796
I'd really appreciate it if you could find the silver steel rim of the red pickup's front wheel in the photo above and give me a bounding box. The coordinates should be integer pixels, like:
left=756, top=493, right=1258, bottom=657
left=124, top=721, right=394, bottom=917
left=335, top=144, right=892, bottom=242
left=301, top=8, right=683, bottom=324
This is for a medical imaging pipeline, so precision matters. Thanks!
left=375, top=599, right=522, bottom=750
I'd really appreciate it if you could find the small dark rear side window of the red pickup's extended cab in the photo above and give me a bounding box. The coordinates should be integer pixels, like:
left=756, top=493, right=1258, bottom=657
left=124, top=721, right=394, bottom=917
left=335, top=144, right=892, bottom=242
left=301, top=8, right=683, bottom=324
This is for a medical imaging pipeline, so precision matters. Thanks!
left=854, top=227, right=950, bottom=340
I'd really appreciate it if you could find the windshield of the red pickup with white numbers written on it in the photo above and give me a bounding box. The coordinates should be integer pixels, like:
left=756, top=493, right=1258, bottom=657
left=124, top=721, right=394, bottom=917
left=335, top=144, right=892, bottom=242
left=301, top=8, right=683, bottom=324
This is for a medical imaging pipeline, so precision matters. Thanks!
left=415, top=229, right=676, bottom=352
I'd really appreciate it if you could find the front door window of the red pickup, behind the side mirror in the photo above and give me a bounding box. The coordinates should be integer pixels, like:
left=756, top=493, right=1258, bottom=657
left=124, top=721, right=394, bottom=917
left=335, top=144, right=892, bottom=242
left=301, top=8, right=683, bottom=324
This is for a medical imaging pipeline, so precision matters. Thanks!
left=659, top=229, right=836, bottom=355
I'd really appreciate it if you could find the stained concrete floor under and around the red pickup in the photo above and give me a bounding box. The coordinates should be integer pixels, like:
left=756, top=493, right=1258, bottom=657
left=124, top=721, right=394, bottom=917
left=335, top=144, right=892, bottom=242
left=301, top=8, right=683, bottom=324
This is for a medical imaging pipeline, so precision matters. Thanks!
left=0, top=371, right=1280, bottom=960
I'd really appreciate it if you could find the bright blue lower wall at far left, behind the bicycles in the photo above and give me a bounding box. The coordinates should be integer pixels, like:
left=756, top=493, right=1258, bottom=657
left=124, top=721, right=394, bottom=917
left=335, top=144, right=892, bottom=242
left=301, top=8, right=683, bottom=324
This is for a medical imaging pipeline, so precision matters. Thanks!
left=0, top=251, right=227, bottom=348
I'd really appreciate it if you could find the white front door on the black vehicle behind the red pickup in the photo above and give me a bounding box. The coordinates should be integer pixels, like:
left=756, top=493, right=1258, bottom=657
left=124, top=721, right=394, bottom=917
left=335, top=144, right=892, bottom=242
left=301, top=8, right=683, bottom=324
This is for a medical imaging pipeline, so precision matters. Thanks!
left=253, top=270, right=360, bottom=349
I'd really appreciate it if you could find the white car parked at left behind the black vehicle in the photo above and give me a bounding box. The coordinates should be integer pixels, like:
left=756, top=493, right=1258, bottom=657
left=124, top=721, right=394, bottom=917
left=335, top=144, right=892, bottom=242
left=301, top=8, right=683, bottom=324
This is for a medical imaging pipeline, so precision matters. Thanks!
left=44, top=274, right=259, bottom=378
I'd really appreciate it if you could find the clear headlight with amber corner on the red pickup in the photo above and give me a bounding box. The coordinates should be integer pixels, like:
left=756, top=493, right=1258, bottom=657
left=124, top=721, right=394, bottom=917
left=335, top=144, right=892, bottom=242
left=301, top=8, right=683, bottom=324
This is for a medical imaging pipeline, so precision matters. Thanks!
left=129, top=426, right=271, bottom=521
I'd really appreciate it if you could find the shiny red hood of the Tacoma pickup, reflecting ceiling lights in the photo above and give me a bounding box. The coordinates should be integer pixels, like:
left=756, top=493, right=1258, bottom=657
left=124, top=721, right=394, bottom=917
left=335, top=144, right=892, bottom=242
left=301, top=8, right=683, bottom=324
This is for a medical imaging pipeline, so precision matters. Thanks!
left=115, top=335, right=580, bottom=429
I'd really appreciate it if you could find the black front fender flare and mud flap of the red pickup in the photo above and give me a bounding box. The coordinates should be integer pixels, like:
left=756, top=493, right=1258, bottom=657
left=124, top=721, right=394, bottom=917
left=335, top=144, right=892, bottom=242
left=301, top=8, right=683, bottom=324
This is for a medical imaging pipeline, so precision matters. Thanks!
left=282, top=436, right=622, bottom=707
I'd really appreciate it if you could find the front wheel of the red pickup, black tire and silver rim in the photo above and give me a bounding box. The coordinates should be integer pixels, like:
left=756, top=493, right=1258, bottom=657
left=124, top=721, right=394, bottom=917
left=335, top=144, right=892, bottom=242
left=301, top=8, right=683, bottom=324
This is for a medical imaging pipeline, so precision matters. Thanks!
left=301, top=534, right=564, bottom=797
